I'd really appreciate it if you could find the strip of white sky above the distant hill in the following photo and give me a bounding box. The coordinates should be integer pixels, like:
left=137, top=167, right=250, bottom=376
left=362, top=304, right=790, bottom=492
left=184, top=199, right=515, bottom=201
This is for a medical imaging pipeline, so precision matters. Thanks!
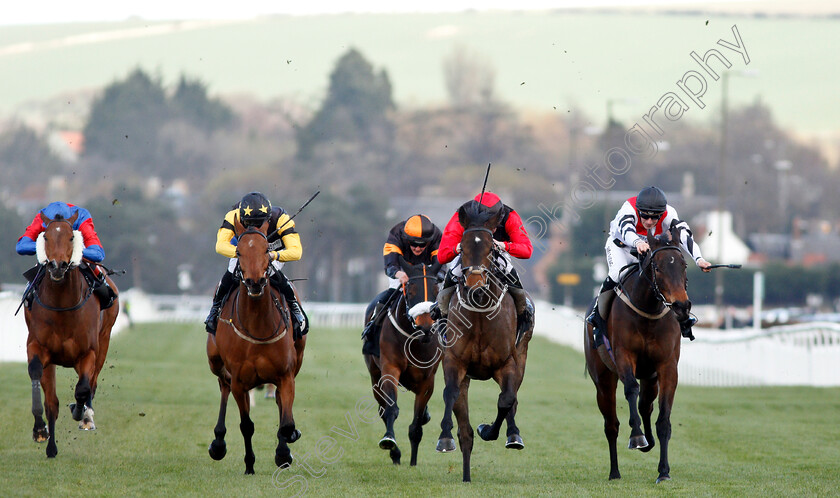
left=0, top=0, right=759, bottom=25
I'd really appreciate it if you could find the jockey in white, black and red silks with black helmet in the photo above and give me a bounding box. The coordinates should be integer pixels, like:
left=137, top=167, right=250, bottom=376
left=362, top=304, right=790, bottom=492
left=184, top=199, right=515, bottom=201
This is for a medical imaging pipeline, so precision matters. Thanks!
left=586, top=187, right=711, bottom=349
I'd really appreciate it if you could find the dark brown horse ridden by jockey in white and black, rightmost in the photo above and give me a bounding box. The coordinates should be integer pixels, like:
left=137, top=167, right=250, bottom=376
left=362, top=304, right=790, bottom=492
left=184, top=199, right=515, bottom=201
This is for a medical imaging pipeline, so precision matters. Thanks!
left=584, top=228, right=691, bottom=482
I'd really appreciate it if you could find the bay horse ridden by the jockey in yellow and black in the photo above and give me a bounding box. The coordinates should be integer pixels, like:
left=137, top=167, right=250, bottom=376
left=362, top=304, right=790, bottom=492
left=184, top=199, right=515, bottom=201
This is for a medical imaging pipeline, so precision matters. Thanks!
left=207, top=220, right=306, bottom=474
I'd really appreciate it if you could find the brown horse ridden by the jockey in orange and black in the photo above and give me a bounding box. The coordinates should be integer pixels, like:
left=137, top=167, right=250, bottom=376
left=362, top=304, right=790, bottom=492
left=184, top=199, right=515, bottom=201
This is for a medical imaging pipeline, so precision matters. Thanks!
left=364, top=257, right=441, bottom=466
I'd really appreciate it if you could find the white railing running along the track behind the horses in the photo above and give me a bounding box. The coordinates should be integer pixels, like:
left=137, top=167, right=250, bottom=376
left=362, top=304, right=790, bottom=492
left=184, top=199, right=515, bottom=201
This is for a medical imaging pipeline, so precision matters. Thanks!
left=0, top=289, right=840, bottom=386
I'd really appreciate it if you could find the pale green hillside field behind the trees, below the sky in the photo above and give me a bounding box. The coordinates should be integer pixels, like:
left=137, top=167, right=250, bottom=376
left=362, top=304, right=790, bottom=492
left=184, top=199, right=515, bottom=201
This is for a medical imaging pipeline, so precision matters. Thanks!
left=0, top=11, right=840, bottom=133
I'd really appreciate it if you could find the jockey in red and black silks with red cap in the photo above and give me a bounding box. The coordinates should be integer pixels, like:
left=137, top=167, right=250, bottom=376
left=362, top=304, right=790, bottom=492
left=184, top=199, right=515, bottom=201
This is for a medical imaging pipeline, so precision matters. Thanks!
left=432, top=192, right=534, bottom=337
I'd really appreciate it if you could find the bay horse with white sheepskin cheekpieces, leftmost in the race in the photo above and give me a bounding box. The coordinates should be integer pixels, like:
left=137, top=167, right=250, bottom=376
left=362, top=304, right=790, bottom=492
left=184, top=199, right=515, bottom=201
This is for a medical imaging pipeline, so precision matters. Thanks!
left=24, top=213, right=119, bottom=458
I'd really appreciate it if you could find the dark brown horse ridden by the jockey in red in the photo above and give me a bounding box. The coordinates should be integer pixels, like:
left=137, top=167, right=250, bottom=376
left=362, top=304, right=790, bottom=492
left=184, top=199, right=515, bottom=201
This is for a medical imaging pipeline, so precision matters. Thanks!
left=436, top=201, right=533, bottom=482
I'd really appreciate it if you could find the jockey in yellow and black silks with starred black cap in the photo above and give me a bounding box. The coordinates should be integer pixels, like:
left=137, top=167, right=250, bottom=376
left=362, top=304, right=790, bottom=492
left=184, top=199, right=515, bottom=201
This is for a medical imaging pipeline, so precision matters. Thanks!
left=204, top=192, right=307, bottom=335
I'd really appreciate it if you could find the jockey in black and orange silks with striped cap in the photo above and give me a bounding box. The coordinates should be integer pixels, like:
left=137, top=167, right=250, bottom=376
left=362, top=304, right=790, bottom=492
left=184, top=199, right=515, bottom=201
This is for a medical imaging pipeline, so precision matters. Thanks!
left=362, top=214, right=441, bottom=354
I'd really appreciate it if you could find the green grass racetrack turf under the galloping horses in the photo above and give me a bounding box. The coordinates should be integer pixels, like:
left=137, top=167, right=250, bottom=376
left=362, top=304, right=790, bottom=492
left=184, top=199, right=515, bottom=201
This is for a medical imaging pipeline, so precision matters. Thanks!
left=0, top=324, right=840, bottom=497
